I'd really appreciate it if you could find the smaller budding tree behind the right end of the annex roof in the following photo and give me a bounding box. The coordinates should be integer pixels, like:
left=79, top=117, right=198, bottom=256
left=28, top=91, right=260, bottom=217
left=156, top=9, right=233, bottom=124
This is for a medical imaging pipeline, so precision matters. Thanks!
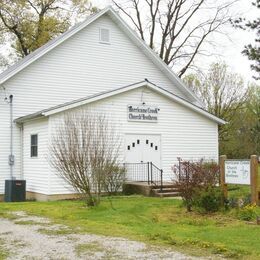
left=184, top=63, right=248, bottom=141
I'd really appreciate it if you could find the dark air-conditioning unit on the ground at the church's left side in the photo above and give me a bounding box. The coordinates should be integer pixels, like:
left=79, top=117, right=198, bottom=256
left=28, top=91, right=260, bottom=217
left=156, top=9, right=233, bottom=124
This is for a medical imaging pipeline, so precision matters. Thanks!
left=5, top=180, right=26, bottom=202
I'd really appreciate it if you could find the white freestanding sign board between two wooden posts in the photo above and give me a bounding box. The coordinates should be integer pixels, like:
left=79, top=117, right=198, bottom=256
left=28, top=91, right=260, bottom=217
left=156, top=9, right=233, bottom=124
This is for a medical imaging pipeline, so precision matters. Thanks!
left=225, top=160, right=250, bottom=185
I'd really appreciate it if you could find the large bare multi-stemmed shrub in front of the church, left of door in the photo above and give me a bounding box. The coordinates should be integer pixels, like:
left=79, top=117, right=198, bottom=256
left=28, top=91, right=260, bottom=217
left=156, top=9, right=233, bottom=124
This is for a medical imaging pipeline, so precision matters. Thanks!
left=50, top=111, right=124, bottom=206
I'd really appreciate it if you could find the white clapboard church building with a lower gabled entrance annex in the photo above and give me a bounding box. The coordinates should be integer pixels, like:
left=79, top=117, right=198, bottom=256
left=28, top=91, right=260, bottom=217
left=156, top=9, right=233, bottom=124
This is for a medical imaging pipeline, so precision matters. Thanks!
left=0, top=7, right=225, bottom=199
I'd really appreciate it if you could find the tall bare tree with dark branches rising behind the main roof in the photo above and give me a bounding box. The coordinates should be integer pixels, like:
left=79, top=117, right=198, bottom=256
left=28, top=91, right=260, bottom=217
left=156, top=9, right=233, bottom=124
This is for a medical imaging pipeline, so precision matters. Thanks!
left=113, top=0, right=236, bottom=77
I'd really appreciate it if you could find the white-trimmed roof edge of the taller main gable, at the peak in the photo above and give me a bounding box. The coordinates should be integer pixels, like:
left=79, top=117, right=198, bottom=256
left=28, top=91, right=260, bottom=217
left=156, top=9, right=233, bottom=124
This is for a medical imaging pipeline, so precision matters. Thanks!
left=0, top=6, right=201, bottom=105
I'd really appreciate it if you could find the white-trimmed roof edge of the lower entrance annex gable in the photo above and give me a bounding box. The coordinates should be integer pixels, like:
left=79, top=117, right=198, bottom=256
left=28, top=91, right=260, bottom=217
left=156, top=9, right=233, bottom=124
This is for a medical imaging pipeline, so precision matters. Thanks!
left=15, top=79, right=226, bottom=124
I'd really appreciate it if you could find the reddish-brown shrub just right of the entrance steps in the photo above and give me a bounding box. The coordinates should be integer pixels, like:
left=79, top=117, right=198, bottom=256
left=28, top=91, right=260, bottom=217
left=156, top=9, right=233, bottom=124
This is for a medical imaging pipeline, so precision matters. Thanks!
left=173, top=158, right=219, bottom=211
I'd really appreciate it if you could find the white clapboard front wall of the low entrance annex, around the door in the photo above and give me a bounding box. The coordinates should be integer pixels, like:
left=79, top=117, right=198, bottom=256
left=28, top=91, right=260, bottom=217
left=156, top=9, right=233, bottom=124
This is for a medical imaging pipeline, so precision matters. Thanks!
left=49, top=88, right=218, bottom=194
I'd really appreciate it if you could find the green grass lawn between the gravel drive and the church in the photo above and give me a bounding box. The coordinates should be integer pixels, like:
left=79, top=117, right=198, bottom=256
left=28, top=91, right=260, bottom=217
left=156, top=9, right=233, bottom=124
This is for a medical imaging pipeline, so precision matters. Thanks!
left=0, top=196, right=260, bottom=259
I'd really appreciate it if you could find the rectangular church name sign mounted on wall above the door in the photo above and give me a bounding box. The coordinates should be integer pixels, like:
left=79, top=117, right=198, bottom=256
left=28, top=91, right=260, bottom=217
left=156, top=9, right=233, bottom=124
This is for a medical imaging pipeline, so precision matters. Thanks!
left=127, top=105, right=159, bottom=123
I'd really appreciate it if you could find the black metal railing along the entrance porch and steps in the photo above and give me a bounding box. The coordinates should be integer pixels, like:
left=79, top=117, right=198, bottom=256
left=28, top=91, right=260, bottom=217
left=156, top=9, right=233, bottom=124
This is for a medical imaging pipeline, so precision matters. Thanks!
left=124, top=162, right=163, bottom=190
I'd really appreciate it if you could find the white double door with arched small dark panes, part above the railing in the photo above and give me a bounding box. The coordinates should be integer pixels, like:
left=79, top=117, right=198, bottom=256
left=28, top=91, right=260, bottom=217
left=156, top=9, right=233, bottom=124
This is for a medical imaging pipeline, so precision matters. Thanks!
left=125, top=134, right=161, bottom=168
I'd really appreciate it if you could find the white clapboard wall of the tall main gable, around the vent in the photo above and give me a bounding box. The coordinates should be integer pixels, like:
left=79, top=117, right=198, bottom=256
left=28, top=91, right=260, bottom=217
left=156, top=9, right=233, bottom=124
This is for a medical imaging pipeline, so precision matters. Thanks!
left=0, top=13, right=195, bottom=194
